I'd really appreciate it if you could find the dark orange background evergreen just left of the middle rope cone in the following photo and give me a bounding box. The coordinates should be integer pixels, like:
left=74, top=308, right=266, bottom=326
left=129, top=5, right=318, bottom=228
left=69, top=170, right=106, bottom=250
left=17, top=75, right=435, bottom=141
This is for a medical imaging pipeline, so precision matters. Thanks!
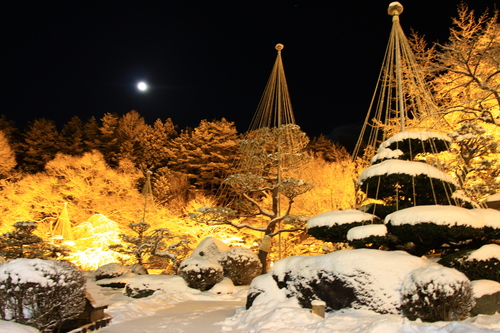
left=168, top=118, right=238, bottom=192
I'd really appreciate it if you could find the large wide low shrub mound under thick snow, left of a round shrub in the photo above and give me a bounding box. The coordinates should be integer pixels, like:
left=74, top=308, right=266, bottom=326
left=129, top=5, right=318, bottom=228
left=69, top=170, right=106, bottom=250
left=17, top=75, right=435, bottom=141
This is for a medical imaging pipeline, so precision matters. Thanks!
left=247, top=249, right=430, bottom=314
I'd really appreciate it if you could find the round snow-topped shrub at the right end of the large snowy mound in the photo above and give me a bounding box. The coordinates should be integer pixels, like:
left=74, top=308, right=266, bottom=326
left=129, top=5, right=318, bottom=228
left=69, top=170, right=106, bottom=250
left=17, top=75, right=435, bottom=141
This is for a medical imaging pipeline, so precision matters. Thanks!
left=401, top=264, right=475, bottom=322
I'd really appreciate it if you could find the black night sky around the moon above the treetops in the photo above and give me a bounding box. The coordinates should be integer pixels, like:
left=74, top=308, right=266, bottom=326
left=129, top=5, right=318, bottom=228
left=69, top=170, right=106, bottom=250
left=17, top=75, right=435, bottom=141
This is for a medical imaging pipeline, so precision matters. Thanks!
left=0, top=0, right=496, bottom=136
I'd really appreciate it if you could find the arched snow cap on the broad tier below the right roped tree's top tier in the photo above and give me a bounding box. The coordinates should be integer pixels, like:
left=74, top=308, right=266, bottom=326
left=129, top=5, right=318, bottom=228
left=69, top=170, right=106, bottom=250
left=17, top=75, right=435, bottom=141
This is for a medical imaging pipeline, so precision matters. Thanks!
left=358, top=160, right=458, bottom=186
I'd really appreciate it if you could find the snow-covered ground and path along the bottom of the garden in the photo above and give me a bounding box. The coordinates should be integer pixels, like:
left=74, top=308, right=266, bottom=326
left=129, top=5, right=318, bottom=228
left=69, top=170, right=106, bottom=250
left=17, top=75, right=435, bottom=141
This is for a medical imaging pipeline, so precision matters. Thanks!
left=0, top=268, right=500, bottom=333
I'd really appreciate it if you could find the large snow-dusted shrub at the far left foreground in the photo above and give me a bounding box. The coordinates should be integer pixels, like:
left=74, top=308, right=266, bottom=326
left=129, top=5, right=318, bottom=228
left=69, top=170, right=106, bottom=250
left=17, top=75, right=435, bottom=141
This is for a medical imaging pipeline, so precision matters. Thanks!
left=0, top=259, right=85, bottom=332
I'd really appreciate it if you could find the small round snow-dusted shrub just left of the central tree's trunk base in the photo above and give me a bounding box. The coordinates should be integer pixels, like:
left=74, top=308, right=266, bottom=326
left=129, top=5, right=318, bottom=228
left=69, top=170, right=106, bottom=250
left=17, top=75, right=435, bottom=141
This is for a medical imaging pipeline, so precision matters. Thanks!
left=219, top=247, right=262, bottom=286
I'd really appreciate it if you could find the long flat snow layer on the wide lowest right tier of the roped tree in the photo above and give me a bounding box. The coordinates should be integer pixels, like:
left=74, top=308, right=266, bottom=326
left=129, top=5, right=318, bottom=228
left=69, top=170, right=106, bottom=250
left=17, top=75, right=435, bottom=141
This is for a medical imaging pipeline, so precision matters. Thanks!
left=384, top=205, right=500, bottom=228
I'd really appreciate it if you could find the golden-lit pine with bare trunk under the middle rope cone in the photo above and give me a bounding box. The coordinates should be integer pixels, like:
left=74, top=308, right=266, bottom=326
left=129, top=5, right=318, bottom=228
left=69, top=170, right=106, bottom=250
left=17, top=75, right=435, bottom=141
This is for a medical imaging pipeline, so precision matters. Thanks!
left=193, top=124, right=313, bottom=272
